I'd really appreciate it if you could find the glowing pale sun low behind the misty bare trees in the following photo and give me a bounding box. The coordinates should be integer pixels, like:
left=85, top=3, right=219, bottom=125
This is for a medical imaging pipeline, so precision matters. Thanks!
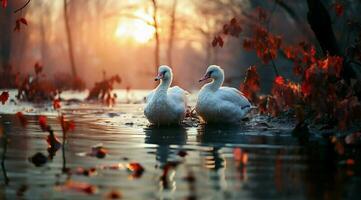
left=115, top=19, right=155, bottom=43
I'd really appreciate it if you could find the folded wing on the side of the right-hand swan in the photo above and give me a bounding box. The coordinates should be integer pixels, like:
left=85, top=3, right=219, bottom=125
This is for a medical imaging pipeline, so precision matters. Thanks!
left=217, top=87, right=251, bottom=108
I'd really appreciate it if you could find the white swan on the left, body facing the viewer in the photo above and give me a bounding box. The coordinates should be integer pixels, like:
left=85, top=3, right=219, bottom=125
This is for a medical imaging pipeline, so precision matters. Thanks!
left=144, top=65, right=188, bottom=125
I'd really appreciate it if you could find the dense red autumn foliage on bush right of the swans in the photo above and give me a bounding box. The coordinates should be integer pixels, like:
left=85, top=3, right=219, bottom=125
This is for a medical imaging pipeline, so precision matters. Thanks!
left=212, top=6, right=361, bottom=129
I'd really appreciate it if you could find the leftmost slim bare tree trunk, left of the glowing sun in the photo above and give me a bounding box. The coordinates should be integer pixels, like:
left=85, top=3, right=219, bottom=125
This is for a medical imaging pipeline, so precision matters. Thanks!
left=64, top=0, right=77, bottom=79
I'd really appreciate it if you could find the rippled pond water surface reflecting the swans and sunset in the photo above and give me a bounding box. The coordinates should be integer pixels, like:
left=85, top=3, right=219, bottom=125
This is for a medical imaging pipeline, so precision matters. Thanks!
left=0, top=91, right=361, bottom=199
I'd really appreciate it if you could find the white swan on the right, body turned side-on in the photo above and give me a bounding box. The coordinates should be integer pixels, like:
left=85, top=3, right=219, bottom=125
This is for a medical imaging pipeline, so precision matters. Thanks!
left=196, top=65, right=251, bottom=123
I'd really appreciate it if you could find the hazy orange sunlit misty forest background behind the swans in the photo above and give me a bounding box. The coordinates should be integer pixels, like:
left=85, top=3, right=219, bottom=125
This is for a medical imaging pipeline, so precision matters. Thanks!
left=0, top=0, right=359, bottom=92
